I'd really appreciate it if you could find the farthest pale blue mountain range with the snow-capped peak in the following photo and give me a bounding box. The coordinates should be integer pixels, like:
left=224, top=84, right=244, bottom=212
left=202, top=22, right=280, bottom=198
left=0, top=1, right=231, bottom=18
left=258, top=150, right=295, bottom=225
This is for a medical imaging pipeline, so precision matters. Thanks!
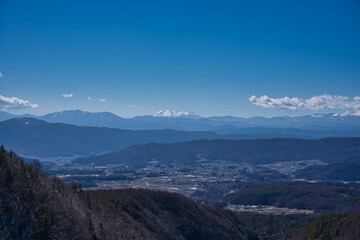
left=0, top=110, right=360, bottom=132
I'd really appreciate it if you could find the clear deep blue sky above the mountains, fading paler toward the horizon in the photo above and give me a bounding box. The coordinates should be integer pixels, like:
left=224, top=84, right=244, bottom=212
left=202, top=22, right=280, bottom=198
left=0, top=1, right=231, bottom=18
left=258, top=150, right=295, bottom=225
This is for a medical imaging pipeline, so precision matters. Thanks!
left=0, top=0, right=360, bottom=117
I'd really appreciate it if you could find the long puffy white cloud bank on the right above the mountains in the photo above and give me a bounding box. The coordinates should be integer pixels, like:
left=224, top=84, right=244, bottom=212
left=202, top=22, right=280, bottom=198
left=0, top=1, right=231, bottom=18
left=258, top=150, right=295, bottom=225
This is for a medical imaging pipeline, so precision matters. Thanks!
left=249, top=94, right=360, bottom=111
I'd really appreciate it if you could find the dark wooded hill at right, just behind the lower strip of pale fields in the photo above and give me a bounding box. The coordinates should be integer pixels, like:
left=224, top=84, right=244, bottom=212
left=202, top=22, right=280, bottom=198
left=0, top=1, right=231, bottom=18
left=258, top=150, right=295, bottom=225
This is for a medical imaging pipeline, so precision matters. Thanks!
left=222, top=181, right=360, bottom=213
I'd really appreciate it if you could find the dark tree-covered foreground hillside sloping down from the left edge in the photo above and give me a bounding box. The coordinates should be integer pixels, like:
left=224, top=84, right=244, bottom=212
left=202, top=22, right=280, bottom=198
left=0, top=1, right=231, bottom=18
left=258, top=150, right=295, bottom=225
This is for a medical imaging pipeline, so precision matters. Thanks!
left=0, top=148, right=257, bottom=239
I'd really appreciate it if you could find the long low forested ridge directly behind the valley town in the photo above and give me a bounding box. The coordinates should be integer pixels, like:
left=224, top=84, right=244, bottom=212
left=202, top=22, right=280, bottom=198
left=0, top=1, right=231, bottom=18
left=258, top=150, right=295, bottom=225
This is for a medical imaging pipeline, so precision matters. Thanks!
left=75, top=138, right=360, bottom=164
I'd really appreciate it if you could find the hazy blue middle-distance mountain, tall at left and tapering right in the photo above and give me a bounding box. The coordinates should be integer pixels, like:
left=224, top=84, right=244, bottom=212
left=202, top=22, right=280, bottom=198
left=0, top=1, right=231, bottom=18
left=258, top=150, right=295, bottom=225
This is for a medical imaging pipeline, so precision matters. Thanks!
left=0, top=114, right=360, bottom=161
